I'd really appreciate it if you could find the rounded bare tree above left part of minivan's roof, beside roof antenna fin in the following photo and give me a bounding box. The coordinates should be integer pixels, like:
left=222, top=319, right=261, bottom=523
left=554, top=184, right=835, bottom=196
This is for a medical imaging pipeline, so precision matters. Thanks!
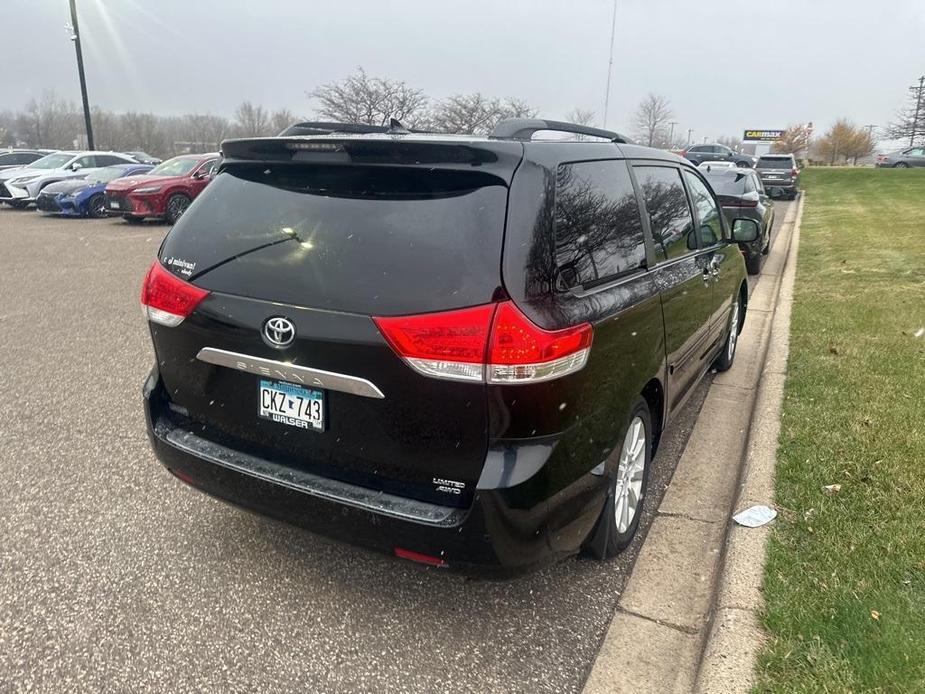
left=309, top=67, right=427, bottom=126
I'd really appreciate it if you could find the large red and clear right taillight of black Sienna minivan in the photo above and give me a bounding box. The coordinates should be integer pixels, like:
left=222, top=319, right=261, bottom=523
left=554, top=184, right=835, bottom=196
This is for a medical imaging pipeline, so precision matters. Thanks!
left=373, top=301, right=593, bottom=383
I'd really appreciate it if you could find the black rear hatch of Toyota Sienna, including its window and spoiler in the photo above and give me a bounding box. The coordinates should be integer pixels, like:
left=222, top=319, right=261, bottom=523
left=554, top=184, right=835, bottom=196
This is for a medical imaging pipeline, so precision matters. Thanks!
left=151, top=138, right=522, bottom=506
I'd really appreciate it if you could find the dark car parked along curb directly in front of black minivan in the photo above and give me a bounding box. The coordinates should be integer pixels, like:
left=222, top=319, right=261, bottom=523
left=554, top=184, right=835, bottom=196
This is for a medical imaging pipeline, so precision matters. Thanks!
left=701, top=167, right=774, bottom=275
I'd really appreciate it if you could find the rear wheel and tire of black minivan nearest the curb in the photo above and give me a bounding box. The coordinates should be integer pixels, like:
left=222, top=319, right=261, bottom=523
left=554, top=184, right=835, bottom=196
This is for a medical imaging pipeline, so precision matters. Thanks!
left=587, top=397, right=653, bottom=559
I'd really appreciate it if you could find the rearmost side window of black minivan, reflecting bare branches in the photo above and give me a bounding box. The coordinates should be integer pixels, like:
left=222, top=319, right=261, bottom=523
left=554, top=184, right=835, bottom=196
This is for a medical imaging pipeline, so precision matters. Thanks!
left=552, top=160, right=646, bottom=289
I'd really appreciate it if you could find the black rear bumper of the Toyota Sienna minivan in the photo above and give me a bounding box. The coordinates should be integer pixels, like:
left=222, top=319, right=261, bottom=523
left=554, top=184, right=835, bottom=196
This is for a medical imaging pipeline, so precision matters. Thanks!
left=144, top=370, right=606, bottom=578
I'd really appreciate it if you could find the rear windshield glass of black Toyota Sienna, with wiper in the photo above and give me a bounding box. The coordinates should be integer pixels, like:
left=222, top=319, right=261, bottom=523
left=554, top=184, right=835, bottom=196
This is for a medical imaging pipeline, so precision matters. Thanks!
left=161, top=164, right=507, bottom=315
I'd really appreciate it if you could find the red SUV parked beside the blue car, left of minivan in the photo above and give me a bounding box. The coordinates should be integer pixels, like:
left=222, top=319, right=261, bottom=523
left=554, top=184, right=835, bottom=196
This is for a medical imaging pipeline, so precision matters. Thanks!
left=106, top=153, right=221, bottom=224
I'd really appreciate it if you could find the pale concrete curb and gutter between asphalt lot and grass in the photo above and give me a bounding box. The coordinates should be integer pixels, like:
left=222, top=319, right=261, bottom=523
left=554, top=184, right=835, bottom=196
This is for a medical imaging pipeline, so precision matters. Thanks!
left=584, top=197, right=803, bottom=694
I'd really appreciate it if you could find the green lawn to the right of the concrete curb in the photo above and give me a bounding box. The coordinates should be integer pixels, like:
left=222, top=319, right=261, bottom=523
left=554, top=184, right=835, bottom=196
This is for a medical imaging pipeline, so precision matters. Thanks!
left=755, top=169, right=925, bottom=693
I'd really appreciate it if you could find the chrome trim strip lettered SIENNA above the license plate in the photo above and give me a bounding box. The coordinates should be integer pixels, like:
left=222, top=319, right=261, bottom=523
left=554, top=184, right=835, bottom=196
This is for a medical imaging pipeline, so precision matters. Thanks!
left=196, top=347, right=385, bottom=399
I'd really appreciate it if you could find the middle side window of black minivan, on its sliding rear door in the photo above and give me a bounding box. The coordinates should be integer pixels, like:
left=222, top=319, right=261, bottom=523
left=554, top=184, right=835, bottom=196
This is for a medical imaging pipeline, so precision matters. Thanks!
left=633, top=166, right=697, bottom=260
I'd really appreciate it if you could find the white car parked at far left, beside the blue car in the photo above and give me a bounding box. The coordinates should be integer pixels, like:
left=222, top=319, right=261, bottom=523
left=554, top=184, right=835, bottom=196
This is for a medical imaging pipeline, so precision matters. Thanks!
left=0, top=151, right=135, bottom=208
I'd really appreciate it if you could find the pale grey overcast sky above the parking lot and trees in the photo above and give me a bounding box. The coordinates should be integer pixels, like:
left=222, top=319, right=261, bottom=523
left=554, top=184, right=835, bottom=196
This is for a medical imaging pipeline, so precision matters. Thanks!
left=0, top=0, right=925, bottom=140
